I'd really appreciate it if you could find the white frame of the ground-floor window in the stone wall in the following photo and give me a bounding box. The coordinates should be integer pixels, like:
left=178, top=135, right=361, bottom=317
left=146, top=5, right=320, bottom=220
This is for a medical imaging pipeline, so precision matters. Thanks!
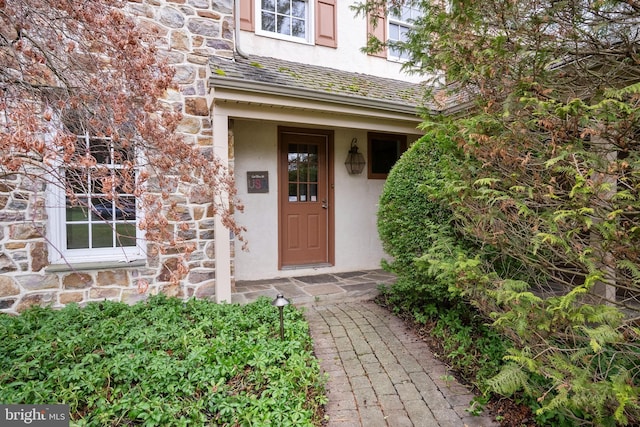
left=45, top=135, right=146, bottom=265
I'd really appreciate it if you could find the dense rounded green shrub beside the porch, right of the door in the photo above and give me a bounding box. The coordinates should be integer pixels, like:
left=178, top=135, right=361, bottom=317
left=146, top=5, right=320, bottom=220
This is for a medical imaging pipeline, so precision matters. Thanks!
left=378, top=135, right=468, bottom=307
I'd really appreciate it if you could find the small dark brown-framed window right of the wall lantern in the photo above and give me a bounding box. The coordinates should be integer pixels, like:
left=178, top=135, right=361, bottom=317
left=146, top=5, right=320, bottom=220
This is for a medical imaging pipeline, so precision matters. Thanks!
left=367, top=132, right=407, bottom=179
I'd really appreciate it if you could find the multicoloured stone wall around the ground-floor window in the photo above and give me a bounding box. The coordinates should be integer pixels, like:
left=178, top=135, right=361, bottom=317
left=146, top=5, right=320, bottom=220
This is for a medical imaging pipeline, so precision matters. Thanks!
left=0, top=0, right=234, bottom=313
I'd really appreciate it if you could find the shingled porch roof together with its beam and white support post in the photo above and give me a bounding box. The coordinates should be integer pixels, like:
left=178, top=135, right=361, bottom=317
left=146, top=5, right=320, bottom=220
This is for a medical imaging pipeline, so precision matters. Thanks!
left=208, top=56, right=429, bottom=301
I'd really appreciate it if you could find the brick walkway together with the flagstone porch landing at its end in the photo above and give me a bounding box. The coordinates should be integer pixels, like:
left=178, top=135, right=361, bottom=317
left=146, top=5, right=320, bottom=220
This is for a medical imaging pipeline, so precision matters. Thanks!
left=232, top=270, right=498, bottom=427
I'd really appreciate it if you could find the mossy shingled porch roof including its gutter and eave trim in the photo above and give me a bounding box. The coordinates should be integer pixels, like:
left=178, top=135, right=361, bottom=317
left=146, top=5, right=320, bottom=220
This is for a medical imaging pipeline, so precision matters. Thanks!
left=209, top=55, right=434, bottom=129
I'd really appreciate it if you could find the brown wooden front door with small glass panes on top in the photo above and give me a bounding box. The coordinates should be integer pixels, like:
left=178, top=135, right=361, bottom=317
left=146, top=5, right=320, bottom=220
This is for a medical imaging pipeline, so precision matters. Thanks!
left=278, top=128, right=333, bottom=268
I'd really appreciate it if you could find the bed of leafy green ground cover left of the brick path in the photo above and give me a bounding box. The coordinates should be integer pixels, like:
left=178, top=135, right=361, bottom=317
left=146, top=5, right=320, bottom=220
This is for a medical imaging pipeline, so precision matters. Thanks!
left=0, top=296, right=325, bottom=426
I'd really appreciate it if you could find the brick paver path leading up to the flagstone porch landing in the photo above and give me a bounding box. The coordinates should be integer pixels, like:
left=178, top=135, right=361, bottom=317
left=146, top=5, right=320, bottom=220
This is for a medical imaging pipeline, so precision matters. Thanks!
left=305, top=302, right=498, bottom=427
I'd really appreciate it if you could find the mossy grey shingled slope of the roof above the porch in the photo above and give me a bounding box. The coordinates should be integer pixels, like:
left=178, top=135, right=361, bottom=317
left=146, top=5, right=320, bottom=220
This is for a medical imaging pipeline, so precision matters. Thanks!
left=209, top=55, right=432, bottom=115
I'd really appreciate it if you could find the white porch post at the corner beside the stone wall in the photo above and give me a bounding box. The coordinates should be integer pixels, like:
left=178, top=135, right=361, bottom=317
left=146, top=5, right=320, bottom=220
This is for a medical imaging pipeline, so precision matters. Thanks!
left=213, top=110, right=231, bottom=303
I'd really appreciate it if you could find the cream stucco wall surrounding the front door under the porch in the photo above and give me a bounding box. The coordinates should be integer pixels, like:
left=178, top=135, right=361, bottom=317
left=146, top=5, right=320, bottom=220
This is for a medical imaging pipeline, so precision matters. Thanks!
left=234, top=119, right=415, bottom=280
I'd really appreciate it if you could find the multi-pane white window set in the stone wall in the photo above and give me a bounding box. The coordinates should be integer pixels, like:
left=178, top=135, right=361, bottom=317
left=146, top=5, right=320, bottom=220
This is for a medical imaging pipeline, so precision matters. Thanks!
left=48, top=134, right=142, bottom=263
